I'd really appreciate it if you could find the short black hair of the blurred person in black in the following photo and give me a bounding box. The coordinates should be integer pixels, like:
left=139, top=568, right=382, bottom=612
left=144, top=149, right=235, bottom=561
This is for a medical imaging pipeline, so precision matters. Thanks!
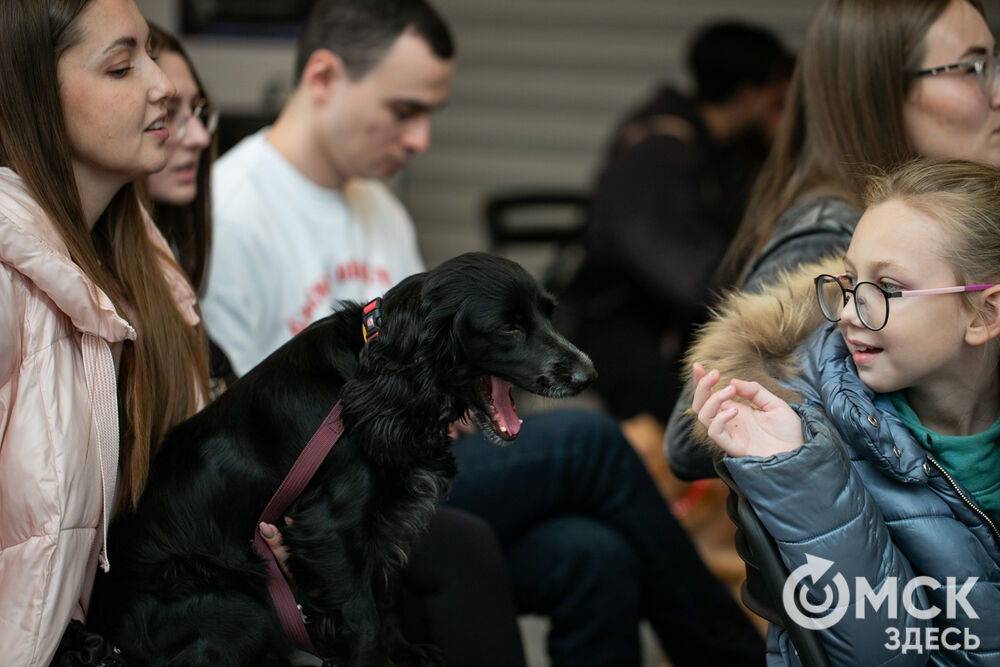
left=688, top=21, right=795, bottom=102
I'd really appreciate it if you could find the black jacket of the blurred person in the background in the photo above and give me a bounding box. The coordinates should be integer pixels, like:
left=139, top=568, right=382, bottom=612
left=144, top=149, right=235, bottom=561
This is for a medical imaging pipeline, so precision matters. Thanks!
left=560, top=88, right=765, bottom=422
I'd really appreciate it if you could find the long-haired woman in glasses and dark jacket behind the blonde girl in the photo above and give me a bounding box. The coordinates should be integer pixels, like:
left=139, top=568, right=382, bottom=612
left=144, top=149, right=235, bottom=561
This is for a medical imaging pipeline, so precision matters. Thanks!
left=664, top=0, right=1000, bottom=479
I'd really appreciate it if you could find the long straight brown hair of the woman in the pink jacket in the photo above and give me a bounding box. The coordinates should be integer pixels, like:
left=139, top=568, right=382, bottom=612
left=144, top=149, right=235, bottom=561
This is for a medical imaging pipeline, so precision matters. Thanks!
left=0, top=0, right=208, bottom=505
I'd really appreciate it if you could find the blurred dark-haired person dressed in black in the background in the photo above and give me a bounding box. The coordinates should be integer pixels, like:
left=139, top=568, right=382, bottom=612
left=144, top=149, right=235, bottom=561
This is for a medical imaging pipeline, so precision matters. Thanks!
left=559, top=22, right=793, bottom=430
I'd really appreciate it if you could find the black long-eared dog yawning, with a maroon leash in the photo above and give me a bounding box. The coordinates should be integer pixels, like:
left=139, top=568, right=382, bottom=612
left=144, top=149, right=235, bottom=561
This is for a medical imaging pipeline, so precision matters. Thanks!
left=88, top=253, right=596, bottom=667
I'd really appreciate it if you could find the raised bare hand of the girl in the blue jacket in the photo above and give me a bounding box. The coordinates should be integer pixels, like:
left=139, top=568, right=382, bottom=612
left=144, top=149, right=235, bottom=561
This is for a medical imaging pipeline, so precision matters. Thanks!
left=691, top=363, right=803, bottom=457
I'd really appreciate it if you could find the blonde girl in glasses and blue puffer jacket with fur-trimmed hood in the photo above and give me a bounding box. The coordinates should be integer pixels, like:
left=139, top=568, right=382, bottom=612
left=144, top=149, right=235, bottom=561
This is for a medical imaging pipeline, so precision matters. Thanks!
left=689, top=160, right=1000, bottom=665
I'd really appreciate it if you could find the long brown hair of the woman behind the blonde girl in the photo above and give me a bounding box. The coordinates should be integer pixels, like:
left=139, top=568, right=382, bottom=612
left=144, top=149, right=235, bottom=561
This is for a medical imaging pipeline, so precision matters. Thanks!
left=720, top=0, right=984, bottom=285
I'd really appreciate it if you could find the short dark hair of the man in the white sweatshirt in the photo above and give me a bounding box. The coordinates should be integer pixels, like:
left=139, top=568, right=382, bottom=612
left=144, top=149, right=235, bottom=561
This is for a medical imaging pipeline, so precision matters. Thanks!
left=295, top=0, right=455, bottom=80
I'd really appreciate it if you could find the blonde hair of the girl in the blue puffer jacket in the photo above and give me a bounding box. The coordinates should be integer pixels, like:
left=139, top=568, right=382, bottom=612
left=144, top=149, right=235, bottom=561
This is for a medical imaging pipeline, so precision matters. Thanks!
left=864, top=159, right=1000, bottom=305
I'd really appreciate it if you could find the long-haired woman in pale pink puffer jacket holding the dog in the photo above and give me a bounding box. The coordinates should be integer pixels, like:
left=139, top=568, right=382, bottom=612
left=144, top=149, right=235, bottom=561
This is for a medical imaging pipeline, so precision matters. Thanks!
left=0, top=0, right=207, bottom=666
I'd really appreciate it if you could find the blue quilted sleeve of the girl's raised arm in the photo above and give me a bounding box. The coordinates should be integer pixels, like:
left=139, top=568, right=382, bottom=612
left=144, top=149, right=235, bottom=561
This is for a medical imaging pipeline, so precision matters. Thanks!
left=725, top=407, right=931, bottom=665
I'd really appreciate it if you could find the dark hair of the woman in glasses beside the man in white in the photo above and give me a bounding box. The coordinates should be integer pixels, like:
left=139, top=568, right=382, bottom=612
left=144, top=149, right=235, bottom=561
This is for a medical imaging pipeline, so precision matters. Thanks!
left=140, top=21, right=218, bottom=293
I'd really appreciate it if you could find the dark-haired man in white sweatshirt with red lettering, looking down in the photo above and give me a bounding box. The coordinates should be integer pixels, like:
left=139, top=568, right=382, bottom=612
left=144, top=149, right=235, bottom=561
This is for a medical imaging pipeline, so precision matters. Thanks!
left=202, top=0, right=455, bottom=375
